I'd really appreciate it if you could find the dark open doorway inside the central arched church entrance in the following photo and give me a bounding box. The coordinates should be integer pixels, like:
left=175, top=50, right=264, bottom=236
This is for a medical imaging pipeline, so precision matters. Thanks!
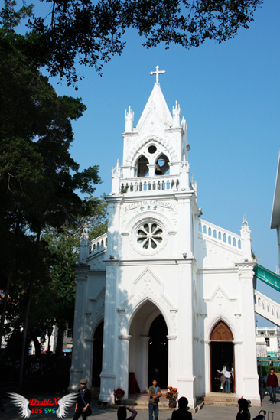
left=148, top=315, right=168, bottom=389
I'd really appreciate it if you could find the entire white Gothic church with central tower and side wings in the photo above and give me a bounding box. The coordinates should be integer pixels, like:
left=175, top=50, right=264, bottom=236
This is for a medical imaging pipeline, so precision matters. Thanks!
left=69, top=67, right=259, bottom=407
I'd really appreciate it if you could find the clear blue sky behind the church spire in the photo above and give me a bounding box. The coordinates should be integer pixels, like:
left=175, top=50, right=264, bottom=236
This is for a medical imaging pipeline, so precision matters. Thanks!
left=18, top=0, right=280, bottom=325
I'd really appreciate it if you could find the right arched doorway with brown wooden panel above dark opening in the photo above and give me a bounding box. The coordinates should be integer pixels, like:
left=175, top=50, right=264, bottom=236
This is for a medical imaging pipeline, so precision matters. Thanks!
left=210, top=321, right=235, bottom=392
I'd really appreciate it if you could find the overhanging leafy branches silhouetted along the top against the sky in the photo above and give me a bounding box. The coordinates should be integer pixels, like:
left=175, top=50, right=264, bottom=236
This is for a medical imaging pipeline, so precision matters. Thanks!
left=2, top=0, right=263, bottom=84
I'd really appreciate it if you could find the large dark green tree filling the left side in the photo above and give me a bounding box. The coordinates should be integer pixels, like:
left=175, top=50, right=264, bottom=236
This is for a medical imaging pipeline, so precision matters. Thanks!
left=0, top=9, right=104, bottom=375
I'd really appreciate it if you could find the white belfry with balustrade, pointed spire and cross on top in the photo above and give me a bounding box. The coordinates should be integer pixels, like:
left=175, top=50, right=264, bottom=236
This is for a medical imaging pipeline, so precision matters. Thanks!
left=112, top=66, right=191, bottom=194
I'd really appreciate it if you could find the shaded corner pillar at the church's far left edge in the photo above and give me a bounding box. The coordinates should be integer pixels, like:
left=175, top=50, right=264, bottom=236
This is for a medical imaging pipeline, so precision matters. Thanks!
left=68, top=263, right=89, bottom=390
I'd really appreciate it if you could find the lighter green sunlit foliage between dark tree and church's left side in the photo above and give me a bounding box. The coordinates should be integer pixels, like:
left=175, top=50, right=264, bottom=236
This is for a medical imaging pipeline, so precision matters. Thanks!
left=39, top=197, right=107, bottom=329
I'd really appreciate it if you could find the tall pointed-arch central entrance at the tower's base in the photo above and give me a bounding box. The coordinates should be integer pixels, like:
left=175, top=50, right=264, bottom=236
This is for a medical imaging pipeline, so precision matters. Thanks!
left=129, top=300, right=168, bottom=393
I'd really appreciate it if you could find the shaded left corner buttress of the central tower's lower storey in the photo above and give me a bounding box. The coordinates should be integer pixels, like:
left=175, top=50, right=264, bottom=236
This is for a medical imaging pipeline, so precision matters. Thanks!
left=99, top=262, right=117, bottom=402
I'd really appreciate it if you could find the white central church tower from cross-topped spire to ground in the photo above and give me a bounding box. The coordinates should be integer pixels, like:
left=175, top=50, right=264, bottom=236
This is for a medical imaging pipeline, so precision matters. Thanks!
left=100, top=67, right=200, bottom=406
